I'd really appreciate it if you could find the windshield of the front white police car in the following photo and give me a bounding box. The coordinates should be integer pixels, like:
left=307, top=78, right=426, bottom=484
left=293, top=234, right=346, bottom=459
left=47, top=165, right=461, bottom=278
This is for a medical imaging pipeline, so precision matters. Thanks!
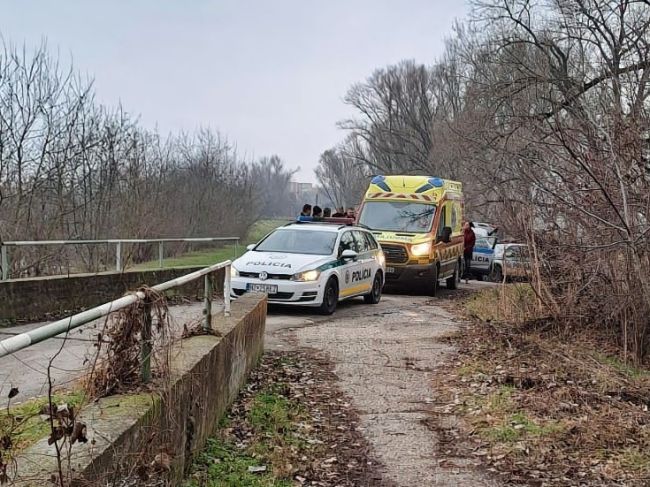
left=255, top=228, right=338, bottom=255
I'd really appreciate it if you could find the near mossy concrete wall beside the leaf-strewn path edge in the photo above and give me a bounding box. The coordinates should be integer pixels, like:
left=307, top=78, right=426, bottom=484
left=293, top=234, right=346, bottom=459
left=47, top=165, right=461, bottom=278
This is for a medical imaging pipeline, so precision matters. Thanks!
left=16, top=294, right=266, bottom=486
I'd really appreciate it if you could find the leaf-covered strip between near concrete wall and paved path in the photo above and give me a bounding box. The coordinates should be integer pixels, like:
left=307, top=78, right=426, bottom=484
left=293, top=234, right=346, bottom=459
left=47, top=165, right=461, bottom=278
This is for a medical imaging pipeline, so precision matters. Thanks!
left=185, top=352, right=381, bottom=487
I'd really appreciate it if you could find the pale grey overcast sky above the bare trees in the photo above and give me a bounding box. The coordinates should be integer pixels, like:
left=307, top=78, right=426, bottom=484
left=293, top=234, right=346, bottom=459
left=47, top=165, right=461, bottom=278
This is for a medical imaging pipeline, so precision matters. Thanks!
left=0, top=0, right=468, bottom=181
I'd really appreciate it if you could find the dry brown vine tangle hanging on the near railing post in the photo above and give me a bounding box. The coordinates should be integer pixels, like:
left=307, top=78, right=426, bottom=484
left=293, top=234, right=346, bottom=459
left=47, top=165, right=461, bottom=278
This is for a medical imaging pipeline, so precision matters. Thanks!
left=85, top=287, right=172, bottom=398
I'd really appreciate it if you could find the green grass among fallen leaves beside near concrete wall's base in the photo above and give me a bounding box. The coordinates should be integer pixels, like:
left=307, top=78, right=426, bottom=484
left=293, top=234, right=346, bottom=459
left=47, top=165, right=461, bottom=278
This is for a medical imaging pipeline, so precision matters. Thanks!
left=185, top=384, right=306, bottom=487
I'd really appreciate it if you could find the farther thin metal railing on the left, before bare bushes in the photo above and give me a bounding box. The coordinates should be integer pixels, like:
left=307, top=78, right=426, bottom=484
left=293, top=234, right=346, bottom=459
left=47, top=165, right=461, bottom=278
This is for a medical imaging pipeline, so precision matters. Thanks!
left=0, top=237, right=239, bottom=281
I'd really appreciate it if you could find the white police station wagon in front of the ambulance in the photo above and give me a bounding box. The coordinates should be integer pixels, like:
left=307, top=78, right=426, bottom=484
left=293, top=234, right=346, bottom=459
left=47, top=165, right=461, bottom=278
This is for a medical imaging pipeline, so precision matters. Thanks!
left=231, top=218, right=386, bottom=314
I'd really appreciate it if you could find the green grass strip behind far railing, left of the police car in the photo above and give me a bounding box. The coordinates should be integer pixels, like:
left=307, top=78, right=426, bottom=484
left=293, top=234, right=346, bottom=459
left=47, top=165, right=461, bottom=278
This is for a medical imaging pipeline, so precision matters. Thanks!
left=133, top=220, right=287, bottom=270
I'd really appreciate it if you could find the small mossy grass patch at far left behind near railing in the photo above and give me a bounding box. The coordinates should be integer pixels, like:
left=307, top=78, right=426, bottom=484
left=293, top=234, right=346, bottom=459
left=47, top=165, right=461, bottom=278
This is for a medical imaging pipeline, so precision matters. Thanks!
left=0, top=391, right=84, bottom=450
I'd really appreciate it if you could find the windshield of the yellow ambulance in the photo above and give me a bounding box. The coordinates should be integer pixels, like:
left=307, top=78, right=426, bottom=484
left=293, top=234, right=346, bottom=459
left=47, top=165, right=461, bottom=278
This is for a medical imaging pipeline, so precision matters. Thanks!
left=359, top=201, right=436, bottom=233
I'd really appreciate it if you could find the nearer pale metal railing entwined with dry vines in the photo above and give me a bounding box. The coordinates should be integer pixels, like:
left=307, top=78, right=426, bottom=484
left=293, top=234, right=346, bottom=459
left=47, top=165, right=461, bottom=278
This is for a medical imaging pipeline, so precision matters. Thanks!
left=0, top=260, right=231, bottom=382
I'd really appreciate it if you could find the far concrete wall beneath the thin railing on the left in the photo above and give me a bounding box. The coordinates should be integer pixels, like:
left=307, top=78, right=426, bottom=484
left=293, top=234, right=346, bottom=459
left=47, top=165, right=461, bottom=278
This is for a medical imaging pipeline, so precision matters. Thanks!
left=0, top=267, right=224, bottom=326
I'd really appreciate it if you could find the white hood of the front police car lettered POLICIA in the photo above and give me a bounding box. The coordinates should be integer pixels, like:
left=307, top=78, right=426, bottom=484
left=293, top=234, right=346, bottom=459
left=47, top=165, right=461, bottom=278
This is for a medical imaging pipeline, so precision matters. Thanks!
left=233, top=254, right=332, bottom=274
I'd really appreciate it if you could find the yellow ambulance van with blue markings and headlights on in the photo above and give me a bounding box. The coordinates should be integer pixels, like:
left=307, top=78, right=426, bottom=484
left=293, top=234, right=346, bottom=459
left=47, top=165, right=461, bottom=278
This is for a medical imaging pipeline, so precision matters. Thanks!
left=358, top=176, right=463, bottom=296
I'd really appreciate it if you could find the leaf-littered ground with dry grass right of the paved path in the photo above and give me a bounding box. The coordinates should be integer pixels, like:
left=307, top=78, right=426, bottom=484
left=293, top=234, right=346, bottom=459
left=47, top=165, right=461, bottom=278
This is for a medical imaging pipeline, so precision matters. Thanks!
left=435, top=284, right=650, bottom=485
